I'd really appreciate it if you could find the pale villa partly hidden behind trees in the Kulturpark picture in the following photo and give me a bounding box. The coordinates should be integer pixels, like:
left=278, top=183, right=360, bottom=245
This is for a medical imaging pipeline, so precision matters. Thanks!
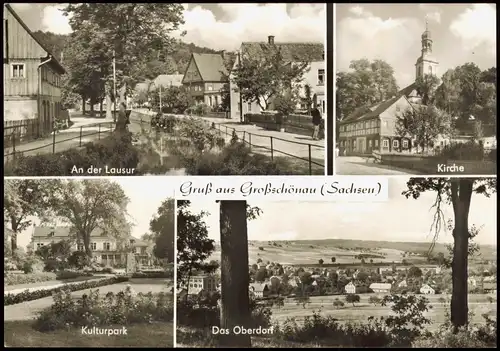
left=30, top=226, right=155, bottom=267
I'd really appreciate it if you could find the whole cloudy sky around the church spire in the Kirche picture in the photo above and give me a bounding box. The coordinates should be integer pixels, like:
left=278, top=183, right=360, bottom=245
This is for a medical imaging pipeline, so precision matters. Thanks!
left=335, top=3, right=497, bottom=88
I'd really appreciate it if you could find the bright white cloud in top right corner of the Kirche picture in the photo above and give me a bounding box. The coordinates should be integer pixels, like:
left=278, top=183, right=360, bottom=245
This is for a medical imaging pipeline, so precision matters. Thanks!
left=450, top=4, right=497, bottom=55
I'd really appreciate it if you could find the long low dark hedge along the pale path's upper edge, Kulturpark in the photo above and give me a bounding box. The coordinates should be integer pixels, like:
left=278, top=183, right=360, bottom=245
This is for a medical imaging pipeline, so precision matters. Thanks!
left=3, top=277, right=128, bottom=306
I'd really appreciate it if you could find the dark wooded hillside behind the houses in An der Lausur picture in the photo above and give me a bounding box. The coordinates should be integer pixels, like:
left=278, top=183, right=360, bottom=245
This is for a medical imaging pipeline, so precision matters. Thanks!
left=33, top=31, right=227, bottom=74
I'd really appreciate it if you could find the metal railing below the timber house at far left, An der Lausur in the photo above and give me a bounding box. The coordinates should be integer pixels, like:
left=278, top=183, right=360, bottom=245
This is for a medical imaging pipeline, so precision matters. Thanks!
left=4, top=122, right=115, bottom=163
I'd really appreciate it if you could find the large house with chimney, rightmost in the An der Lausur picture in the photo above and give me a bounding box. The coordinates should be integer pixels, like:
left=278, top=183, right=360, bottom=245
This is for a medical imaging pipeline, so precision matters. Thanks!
left=229, top=35, right=326, bottom=119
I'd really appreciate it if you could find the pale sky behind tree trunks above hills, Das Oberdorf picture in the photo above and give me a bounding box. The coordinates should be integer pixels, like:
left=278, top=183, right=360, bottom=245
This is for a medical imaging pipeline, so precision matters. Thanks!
left=187, top=177, right=497, bottom=246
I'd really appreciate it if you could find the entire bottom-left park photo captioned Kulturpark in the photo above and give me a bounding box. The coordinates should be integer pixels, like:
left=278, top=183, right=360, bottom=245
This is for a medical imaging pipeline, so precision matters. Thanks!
left=4, top=177, right=175, bottom=348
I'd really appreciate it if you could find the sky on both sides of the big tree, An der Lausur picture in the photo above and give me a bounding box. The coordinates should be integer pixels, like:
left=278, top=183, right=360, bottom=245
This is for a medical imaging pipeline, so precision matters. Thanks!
left=12, top=3, right=326, bottom=50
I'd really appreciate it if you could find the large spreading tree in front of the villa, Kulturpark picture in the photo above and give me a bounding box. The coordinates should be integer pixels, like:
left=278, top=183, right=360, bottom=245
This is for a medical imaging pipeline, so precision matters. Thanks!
left=50, top=179, right=131, bottom=257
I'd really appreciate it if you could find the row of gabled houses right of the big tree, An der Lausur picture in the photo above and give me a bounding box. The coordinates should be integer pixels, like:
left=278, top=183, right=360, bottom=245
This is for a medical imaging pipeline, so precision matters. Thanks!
left=135, top=35, right=326, bottom=119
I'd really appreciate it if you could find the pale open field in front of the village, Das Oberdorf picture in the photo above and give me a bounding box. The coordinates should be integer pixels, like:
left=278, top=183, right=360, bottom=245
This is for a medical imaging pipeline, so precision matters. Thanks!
left=272, top=294, right=497, bottom=330
